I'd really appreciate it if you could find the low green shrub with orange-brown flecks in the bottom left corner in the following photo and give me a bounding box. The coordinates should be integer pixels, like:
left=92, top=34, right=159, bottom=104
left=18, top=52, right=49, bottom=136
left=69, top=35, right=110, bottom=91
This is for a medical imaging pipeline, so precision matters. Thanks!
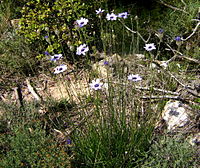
left=0, top=127, right=70, bottom=168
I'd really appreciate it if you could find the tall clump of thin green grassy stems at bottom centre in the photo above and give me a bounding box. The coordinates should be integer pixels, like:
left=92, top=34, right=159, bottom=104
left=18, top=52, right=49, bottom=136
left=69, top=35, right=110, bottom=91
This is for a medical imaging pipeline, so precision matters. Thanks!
left=72, top=77, right=159, bottom=168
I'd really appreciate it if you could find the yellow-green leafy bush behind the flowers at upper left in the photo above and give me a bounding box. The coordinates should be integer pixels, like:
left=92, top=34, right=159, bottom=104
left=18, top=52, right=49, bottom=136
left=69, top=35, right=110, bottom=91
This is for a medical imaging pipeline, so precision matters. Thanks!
left=19, top=0, right=101, bottom=58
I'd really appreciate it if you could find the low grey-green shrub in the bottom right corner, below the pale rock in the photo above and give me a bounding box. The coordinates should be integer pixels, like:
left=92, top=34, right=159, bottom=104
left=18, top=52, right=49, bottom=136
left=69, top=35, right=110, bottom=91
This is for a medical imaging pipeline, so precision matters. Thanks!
left=141, top=136, right=199, bottom=168
